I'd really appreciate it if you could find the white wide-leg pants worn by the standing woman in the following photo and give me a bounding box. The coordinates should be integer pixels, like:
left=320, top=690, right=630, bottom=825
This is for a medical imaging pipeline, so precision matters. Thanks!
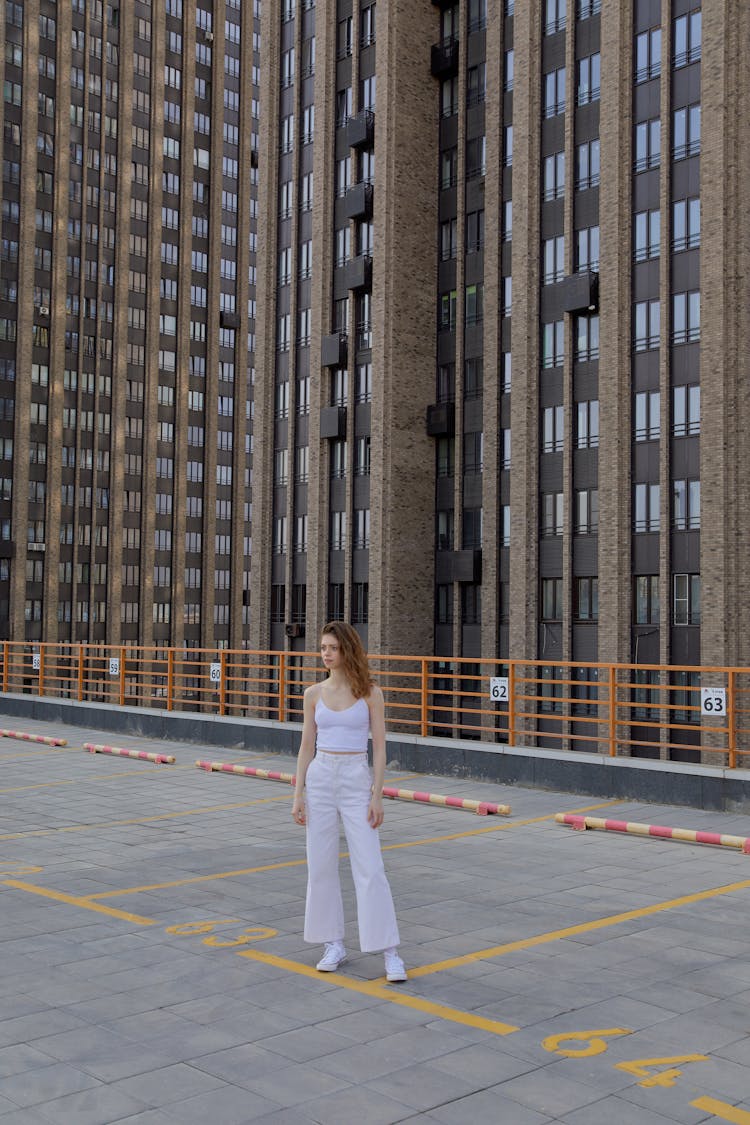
left=305, top=754, right=399, bottom=953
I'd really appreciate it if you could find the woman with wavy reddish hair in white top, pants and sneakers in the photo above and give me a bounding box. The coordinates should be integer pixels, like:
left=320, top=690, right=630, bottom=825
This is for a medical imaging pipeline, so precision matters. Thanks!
left=291, top=621, right=406, bottom=981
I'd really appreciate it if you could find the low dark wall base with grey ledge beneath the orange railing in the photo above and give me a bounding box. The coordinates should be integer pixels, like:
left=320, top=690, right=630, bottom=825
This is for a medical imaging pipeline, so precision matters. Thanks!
left=0, top=695, right=750, bottom=812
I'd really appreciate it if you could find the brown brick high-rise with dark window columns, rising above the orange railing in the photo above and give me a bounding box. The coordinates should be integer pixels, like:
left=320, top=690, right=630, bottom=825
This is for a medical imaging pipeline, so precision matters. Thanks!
left=0, top=0, right=750, bottom=711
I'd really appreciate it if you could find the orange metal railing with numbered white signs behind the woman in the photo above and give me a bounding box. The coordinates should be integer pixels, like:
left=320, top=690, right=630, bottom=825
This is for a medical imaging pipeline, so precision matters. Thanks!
left=0, top=641, right=750, bottom=768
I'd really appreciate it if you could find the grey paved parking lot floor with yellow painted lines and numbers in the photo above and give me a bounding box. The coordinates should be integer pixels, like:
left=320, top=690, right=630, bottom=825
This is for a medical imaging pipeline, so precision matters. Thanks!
left=0, top=720, right=750, bottom=1125
